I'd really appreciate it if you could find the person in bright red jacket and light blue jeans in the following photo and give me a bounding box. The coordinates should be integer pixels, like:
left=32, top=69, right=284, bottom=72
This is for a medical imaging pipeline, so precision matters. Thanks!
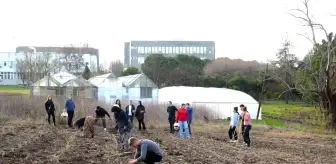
left=176, top=104, right=190, bottom=138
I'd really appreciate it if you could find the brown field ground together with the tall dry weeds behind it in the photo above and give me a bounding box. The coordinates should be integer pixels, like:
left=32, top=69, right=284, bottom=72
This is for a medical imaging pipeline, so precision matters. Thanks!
left=0, top=96, right=336, bottom=164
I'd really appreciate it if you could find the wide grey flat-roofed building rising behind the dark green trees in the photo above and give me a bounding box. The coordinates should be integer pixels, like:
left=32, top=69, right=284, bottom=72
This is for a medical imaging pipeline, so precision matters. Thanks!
left=124, top=41, right=215, bottom=68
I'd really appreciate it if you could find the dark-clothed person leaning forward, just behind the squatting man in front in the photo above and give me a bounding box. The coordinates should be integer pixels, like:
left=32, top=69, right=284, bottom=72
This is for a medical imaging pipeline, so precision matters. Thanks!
left=111, top=104, right=132, bottom=149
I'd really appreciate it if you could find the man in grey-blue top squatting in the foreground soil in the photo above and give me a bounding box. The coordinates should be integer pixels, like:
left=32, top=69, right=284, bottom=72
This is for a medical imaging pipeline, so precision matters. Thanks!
left=128, top=137, right=163, bottom=164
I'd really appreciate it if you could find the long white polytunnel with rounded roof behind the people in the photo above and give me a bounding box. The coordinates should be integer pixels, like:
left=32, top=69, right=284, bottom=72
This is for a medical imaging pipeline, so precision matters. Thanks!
left=158, top=86, right=261, bottom=119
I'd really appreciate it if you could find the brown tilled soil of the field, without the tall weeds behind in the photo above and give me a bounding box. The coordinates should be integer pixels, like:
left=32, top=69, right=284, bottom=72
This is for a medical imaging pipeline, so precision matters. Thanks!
left=0, top=123, right=336, bottom=164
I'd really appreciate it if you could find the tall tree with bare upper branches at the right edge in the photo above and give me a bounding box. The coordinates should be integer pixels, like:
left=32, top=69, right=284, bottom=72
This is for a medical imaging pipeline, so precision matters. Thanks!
left=290, top=0, right=336, bottom=129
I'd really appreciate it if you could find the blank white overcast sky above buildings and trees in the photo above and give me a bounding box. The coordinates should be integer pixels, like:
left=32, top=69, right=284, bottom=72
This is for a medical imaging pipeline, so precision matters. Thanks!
left=0, top=0, right=336, bottom=66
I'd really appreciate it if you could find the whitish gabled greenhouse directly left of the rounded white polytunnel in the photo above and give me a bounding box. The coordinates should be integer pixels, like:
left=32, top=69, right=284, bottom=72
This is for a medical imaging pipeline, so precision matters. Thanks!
left=89, top=73, right=158, bottom=104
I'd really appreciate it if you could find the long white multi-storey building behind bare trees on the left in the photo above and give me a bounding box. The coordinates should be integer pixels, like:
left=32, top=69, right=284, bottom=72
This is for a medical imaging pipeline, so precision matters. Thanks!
left=0, top=46, right=99, bottom=85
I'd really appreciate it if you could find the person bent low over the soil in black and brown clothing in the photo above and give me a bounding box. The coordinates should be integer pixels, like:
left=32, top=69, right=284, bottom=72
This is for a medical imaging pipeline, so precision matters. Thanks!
left=73, top=116, right=95, bottom=138
